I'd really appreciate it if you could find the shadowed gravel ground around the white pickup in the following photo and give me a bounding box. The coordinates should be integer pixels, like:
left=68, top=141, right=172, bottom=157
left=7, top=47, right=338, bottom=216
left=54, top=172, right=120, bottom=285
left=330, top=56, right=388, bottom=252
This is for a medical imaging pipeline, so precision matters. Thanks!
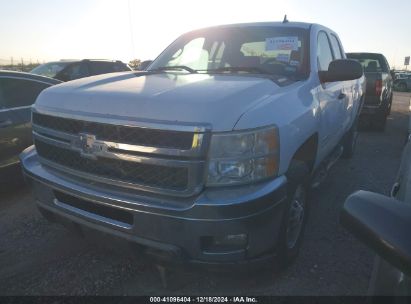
left=0, top=93, right=411, bottom=295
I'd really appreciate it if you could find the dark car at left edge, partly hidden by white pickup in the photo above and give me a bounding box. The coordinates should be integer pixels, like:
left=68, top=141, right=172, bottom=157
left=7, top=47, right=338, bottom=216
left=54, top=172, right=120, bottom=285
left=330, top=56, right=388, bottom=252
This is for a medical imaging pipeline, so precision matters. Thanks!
left=0, top=71, right=61, bottom=180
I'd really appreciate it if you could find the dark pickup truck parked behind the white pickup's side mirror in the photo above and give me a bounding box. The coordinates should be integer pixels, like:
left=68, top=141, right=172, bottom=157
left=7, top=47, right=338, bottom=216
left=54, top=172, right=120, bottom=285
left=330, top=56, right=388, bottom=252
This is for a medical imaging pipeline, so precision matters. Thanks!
left=347, top=53, right=393, bottom=131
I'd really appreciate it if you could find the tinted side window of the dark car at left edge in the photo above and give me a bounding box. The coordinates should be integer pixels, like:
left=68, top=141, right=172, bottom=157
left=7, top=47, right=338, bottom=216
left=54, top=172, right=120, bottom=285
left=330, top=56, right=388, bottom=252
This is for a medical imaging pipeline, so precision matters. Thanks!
left=0, top=78, right=50, bottom=108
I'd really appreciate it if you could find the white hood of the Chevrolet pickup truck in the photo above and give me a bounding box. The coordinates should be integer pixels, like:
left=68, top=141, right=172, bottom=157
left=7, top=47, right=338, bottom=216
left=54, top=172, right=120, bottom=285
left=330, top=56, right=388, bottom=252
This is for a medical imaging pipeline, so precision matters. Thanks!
left=35, top=72, right=281, bottom=131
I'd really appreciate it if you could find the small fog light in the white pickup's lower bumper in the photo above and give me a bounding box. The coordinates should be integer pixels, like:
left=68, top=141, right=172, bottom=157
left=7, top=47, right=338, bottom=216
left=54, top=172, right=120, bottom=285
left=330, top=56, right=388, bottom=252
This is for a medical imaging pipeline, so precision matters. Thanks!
left=201, top=233, right=248, bottom=253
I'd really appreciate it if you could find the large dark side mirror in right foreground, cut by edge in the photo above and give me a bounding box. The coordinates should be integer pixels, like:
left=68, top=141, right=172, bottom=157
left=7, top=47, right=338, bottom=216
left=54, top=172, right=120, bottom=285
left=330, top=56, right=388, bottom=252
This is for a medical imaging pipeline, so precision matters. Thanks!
left=340, top=191, right=411, bottom=275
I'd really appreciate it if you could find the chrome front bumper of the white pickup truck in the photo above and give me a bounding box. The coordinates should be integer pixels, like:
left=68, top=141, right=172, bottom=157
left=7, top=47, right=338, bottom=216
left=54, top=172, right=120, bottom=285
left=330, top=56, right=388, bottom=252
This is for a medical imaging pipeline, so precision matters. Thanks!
left=21, top=148, right=287, bottom=265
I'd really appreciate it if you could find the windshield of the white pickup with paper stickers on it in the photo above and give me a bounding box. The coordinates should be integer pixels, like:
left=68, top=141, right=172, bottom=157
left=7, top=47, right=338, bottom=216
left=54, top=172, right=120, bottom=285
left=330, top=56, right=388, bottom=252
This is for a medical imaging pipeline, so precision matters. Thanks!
left=149, top=26, right=309, bottom=78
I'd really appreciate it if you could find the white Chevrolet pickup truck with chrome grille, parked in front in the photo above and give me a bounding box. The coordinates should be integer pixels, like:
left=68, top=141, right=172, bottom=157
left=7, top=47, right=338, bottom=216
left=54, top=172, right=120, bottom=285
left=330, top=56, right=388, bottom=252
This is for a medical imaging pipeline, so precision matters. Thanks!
left=21, top=22, right=364, bottom=266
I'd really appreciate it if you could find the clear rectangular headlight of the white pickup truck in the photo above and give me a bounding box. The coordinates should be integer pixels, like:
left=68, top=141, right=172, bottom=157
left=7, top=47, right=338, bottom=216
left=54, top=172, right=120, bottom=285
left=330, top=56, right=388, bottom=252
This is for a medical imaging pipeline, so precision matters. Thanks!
left=207, top=127, right=279, bottom=186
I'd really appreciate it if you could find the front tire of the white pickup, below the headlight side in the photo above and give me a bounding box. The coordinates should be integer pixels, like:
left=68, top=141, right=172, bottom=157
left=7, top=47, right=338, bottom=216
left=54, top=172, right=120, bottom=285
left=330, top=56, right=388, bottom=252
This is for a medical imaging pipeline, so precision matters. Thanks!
left=278, top=162, right=309, bottom=269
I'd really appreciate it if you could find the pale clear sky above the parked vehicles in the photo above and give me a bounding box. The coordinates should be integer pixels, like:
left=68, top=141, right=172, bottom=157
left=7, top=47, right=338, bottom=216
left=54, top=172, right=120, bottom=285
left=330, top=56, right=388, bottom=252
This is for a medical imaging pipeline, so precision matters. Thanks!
left=0, top=0, right=411, bottom=69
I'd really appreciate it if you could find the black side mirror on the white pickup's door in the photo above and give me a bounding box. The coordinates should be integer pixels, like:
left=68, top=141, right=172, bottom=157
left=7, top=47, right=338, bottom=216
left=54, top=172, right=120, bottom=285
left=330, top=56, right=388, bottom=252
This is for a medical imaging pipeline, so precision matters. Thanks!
left=320, top=59, right=364, bottom=82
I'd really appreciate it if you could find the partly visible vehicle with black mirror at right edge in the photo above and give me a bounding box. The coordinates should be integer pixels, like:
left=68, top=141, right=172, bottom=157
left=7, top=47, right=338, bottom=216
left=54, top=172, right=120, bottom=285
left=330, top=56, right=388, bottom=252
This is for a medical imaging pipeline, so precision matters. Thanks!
left=341, top=141, right=411, bottom=296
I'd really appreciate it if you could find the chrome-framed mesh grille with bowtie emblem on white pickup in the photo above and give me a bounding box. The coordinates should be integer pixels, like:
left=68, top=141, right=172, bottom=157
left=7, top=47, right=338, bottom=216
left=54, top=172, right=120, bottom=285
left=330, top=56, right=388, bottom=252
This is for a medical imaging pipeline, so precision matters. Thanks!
left=32, top=112, right=210, bottom=197
